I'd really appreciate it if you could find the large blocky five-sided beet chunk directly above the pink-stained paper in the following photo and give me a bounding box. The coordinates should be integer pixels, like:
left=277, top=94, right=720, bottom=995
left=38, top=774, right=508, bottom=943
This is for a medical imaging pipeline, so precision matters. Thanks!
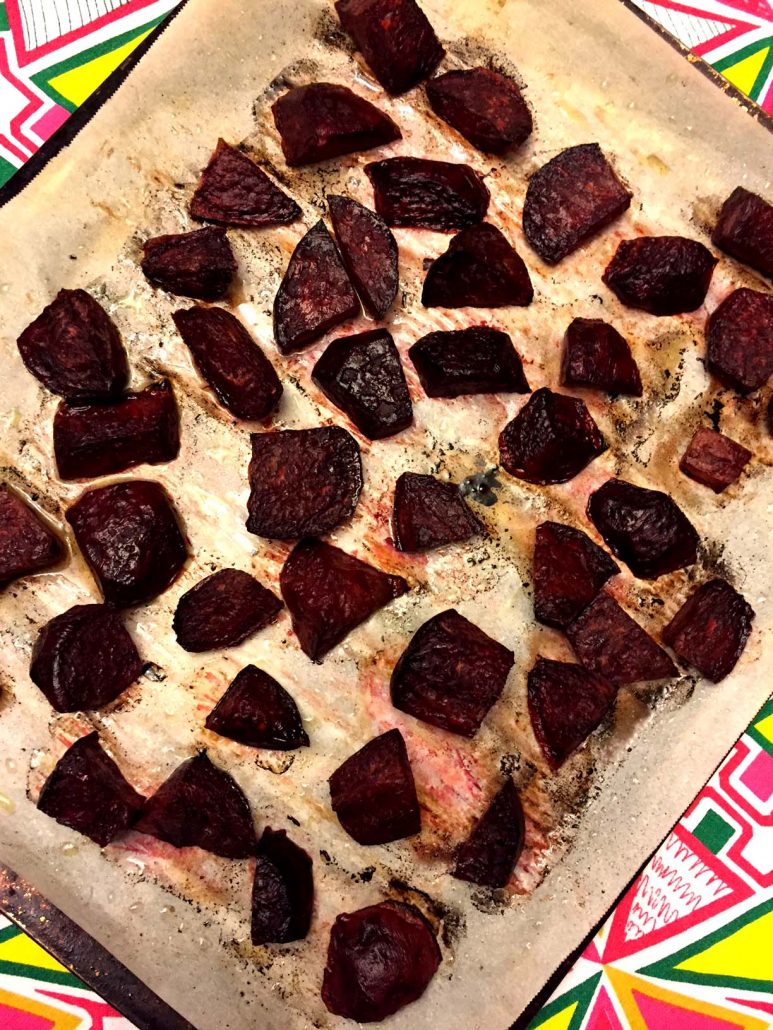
left=390, top=608, right=514, bottom=736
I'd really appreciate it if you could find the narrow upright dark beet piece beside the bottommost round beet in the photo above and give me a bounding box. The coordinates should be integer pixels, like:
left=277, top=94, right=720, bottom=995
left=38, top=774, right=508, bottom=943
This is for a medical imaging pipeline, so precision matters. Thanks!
left=251, top=827, right=314, bottom=945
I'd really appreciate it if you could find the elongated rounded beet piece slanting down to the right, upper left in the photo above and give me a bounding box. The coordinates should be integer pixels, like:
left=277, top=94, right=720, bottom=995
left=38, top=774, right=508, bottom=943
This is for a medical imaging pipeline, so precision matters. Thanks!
left=172, top=306, right=282, bottom=421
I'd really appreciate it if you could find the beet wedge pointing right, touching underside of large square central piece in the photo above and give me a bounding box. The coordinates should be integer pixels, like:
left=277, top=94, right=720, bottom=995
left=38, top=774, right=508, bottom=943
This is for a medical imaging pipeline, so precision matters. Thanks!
left=279, top=540, right=408, bottom=661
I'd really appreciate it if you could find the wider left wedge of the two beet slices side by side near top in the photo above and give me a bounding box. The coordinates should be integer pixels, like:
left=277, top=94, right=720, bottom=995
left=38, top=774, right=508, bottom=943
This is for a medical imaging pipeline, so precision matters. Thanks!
left=274, top=221, right=360, bottom=354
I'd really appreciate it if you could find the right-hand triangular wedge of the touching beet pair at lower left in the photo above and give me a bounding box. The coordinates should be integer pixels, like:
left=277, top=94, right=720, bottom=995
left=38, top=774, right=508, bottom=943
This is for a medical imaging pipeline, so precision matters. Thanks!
left=135, top=751, right=257, bottom=858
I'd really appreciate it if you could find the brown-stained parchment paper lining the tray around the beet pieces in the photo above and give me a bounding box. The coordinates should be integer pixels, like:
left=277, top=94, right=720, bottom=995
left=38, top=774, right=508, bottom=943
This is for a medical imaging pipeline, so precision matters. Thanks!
left=0, top=0, right=772, bottom=1028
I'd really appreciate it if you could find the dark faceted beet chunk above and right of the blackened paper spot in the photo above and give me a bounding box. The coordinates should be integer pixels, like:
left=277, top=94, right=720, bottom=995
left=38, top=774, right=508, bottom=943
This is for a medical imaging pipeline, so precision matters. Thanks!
left=499, top=386, right=607, bottom=484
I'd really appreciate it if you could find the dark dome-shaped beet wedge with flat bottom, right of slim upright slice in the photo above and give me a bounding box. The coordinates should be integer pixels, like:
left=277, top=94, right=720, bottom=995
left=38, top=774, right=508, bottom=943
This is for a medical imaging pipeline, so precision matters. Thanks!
left=422, top=222, right=534, bottom=308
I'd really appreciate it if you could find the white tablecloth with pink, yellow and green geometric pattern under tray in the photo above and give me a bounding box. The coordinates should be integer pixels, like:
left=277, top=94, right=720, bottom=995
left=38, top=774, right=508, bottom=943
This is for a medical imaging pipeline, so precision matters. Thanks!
left=0, top=0, right=773, bottom=1030
